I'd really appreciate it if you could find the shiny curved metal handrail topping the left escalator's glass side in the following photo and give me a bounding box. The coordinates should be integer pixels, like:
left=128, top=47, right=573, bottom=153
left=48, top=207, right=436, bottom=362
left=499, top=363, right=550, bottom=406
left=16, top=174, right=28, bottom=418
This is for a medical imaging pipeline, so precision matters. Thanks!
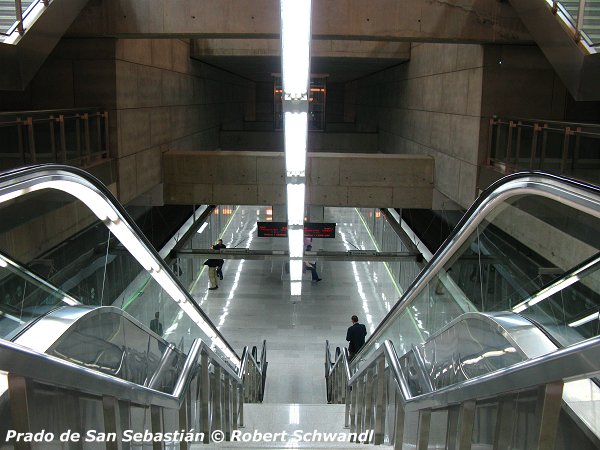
left=0, top=164, right=239, bottom=365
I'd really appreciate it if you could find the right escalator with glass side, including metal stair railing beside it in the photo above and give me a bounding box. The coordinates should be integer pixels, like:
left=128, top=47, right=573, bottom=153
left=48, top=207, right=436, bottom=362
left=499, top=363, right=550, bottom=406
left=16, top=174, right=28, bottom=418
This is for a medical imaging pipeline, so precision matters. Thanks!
left=325, top=173, right=600, bottom=449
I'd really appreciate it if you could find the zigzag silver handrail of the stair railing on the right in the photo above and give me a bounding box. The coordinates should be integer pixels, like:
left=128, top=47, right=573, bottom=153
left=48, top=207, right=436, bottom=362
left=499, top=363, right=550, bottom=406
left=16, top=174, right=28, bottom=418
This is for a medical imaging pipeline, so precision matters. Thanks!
left=348, top=336, right=600, bottom=411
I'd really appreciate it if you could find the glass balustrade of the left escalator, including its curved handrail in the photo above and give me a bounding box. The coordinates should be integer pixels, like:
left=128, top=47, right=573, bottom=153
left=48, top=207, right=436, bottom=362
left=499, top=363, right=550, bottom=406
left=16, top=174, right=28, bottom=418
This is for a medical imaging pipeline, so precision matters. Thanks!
left=0, top=166, right=239, bottom=367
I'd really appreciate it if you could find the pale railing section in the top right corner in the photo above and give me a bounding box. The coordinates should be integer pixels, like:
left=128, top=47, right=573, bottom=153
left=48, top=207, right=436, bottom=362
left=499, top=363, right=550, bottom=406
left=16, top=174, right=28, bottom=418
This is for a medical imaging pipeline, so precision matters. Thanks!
left=546, top=0, right=600, bottom=47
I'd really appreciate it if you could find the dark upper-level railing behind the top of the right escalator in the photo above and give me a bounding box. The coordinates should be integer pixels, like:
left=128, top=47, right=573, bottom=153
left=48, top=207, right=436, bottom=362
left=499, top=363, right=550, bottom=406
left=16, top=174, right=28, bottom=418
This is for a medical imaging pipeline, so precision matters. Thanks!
left=488, top=117, right=600, bottom=182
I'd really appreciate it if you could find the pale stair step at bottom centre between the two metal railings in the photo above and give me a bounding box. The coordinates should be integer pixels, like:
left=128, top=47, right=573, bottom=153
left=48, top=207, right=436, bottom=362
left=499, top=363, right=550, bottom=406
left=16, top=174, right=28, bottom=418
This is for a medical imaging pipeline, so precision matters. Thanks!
left=191, top=403, right=381, bottom=450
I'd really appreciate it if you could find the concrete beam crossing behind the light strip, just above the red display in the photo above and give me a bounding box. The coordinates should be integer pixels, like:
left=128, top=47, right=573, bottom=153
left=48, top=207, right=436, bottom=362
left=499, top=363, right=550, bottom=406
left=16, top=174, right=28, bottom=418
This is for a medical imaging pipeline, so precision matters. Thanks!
left=163, top=150, right=434, bottom=208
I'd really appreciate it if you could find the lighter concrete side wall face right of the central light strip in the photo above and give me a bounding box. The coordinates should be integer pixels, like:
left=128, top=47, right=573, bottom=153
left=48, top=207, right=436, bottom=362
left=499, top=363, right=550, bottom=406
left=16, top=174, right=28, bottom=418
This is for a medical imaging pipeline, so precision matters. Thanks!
left=348, top=44, right=483, bottom=207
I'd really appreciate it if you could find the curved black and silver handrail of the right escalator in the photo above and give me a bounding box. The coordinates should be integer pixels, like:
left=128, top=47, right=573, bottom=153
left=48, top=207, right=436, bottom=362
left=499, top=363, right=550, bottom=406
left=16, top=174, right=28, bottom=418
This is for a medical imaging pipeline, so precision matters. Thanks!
left=353, top=171, right=600, bottom=364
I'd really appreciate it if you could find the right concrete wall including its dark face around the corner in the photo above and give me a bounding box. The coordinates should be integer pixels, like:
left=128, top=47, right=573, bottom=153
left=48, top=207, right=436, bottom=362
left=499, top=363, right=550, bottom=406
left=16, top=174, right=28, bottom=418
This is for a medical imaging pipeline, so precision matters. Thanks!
left=346, top=44, right=589, bottom=209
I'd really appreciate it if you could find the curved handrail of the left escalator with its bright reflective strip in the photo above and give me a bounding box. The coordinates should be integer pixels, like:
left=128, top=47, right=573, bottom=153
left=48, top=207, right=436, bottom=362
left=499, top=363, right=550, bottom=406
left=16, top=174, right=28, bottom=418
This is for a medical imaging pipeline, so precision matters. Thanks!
left=0, top=164, right=240, bottom=366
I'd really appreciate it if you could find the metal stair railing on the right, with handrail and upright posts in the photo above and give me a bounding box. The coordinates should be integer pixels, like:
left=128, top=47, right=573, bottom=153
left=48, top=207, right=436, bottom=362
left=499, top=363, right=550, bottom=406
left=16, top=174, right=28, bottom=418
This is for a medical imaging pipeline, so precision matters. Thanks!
left=326, top=337, right=600, bottom=449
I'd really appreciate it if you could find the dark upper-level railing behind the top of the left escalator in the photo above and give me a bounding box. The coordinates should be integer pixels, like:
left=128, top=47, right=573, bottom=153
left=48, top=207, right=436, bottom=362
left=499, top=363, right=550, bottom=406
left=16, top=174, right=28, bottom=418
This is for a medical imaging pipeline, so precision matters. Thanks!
left=0, top=108, right=109, bottom=168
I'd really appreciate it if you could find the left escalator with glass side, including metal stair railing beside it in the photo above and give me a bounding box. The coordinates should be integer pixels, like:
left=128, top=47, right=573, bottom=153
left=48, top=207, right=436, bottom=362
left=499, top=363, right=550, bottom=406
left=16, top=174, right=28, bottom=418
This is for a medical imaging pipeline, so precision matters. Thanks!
left=0, top=165, right=268, bottom=449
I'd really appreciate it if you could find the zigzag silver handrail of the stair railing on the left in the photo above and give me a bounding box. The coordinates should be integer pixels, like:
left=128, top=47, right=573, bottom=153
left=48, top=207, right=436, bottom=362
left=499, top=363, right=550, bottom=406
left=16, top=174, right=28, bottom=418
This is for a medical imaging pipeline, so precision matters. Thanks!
left=0, top=339, right=242, bottom=409
